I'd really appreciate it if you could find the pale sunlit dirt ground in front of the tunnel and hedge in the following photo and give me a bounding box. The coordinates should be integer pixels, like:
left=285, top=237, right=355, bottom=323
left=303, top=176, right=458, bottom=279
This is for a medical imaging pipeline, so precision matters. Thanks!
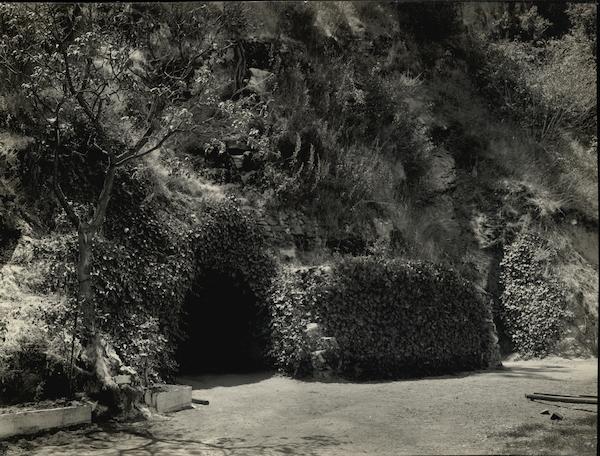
left=0, top=358, right=598, bottom=456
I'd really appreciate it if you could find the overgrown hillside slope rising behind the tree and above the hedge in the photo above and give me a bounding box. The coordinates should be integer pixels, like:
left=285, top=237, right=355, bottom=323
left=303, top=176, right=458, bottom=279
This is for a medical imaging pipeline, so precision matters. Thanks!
left=0, top=2, right=598, bottom=402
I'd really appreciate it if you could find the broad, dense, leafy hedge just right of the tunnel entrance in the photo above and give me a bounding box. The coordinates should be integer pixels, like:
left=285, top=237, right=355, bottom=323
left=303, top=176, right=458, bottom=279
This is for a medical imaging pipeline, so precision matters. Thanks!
left=270, top=256, right=499, bottom=378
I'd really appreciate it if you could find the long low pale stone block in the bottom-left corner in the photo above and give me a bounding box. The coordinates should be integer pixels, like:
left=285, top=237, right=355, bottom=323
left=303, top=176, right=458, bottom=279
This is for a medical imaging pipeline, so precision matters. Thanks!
left=0, top=405, right=92, bottom=439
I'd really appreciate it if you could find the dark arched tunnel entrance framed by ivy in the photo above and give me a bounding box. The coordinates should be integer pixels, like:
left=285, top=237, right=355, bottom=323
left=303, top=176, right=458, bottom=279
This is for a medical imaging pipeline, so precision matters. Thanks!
left=175, top=272, right=269, bottom=375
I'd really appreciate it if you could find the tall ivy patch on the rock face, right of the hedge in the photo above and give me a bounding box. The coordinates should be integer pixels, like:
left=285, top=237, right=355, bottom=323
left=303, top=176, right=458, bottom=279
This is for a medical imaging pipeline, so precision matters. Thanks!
left=500, top=232, right=570, bottom=356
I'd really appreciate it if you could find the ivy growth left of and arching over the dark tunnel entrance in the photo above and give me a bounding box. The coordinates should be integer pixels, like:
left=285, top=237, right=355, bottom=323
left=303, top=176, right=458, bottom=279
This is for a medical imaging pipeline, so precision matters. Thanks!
left=31, top=166, right=275, bottom=390
